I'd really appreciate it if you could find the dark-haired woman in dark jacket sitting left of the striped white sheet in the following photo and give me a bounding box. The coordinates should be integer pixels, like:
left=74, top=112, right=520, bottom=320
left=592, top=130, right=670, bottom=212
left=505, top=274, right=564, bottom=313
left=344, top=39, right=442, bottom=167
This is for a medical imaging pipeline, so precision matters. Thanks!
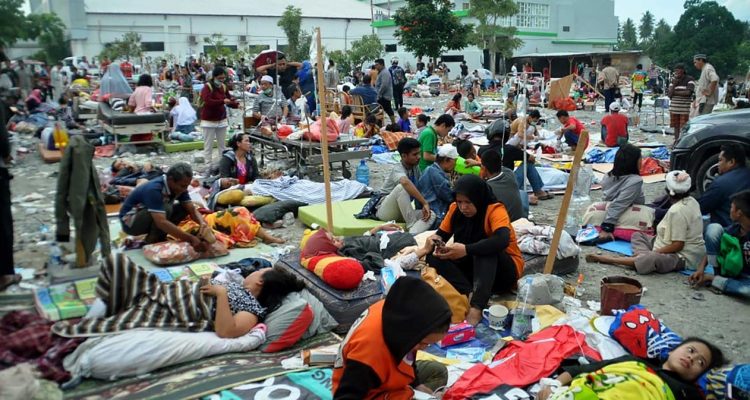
left=219, top=132, right=260, bottom=189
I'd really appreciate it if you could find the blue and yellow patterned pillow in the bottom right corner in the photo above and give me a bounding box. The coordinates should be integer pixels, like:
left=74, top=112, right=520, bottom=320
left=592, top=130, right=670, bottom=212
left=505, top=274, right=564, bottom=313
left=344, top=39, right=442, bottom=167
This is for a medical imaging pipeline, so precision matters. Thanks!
left=698, top=364, right=750, bottom=400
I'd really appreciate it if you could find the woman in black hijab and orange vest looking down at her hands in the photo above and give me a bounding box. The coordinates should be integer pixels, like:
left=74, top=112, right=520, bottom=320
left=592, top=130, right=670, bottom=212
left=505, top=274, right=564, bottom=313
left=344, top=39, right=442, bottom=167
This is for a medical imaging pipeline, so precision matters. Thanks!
left=427, top=175, right=523, bottom=325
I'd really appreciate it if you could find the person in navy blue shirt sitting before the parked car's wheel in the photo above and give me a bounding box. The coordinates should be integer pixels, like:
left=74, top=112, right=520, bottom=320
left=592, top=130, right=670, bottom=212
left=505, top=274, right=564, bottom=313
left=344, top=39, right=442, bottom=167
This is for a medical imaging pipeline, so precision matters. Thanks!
left=698, top=144, right=750, bottom=228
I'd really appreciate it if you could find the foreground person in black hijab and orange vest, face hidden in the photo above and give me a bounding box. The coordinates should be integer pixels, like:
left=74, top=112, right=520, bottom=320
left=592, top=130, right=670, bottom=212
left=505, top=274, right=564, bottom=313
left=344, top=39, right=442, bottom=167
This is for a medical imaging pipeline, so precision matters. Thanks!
left=331, top=276, right=451, bottom=400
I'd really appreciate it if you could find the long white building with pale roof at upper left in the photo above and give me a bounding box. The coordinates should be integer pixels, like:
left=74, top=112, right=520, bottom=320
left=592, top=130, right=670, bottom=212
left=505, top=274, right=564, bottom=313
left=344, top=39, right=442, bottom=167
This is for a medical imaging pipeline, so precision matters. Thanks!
left=31, top=0, right=382, bottom=59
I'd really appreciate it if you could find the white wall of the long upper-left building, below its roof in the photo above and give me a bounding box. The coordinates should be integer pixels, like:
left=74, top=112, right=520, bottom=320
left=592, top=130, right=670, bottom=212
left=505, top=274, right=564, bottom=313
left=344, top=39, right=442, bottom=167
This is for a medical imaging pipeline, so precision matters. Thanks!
left=71, top=13, right=372, bottom=59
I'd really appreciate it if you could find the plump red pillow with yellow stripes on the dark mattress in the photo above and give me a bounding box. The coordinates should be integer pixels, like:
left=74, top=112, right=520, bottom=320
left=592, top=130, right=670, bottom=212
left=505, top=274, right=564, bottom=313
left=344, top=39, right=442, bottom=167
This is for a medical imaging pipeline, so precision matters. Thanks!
left=300, top=254, right=365, bottom=290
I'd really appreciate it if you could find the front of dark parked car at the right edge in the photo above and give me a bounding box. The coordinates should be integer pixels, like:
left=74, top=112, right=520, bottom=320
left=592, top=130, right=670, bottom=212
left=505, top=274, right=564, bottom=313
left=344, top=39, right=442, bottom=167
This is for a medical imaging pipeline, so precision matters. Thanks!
left=670, top=109, right=750, bottom=194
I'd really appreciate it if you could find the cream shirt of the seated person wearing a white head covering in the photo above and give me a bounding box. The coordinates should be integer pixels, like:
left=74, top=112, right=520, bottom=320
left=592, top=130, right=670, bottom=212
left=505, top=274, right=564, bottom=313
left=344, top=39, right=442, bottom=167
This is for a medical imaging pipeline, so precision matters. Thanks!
left=654, top=197, right=706, bottom=268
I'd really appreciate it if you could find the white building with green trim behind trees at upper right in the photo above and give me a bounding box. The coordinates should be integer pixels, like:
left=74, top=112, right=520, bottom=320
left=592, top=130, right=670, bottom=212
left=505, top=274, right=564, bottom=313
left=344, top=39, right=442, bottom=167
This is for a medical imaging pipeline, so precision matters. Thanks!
left=373, top=0, right=617, bottom=76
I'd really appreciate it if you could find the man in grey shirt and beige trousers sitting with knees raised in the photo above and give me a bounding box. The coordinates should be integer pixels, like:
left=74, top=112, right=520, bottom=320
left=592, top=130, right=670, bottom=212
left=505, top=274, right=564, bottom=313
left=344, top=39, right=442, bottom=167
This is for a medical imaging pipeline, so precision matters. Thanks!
left=375, top=138, right=436, bottom=235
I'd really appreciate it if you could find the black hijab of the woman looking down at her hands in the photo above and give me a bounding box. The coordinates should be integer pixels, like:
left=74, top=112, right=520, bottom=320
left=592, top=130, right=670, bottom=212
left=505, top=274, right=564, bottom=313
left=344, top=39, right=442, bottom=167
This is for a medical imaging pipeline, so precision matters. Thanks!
left=451, top=175, right=497, bottom=244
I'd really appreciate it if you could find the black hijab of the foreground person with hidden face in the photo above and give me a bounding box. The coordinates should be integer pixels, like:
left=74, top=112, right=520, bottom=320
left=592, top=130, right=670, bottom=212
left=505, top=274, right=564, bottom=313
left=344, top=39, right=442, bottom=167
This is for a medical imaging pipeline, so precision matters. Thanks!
left=383, top=276, right=452, bottom=363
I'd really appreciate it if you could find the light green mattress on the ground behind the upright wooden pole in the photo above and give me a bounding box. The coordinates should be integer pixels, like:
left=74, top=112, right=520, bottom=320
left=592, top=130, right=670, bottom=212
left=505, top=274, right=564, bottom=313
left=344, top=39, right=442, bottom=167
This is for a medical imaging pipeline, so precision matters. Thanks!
left=299, top=199, right=403, bottom=236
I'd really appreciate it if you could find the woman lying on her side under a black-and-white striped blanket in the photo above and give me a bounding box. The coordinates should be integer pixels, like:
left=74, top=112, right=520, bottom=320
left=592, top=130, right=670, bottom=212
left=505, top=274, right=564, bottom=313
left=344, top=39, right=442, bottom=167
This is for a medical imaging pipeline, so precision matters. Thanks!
left=52, top=253, right=304, bottom=338
